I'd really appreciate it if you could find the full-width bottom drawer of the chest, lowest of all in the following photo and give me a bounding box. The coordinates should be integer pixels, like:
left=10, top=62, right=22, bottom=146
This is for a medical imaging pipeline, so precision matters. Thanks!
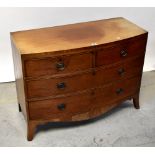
left=29, top=77, right=140, bottom=121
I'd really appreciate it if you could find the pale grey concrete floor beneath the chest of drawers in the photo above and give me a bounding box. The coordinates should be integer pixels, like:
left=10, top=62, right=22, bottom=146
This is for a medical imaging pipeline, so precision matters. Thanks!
left=0, top=71, right=155, bottom=147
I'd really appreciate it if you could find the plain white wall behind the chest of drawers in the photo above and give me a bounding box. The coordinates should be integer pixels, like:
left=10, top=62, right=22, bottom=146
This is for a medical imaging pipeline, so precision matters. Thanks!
left=0, top=8, right=155, bottom=82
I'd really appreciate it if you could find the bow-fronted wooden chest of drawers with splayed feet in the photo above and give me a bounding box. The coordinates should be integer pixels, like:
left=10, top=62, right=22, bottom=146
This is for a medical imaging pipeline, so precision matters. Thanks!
left=11, top=17, right=148, bottom=140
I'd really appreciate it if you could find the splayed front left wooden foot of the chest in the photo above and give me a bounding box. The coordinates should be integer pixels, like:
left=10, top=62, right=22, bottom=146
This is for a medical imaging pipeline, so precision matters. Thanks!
left=27, top=121, right=37, bottom=141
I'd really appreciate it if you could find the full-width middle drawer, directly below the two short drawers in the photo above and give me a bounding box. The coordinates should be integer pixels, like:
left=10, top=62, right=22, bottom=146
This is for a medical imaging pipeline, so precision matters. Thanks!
left=26, top=57, right=143, bottom=99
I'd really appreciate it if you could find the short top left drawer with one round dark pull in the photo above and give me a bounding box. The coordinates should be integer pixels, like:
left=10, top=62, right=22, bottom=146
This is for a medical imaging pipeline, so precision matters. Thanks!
left=24, top=53, right=92, bottom=77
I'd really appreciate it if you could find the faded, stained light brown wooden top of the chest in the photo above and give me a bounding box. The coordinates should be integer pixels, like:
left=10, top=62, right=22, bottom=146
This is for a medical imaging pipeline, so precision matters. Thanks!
left=11, top=17, right=146, bottom=54
